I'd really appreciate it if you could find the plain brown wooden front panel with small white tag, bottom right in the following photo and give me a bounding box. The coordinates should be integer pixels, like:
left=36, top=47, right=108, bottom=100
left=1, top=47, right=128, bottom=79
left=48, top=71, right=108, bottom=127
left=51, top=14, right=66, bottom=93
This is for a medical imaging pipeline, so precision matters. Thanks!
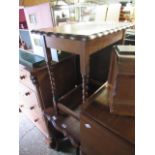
left=80, top=116, right=134, bottom=155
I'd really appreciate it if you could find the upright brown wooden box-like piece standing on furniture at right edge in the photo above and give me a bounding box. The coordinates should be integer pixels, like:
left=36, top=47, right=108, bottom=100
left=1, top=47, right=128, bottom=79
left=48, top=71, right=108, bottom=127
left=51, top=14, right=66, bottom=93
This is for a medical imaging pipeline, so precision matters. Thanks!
left=108, top=45, right=135, bottom=116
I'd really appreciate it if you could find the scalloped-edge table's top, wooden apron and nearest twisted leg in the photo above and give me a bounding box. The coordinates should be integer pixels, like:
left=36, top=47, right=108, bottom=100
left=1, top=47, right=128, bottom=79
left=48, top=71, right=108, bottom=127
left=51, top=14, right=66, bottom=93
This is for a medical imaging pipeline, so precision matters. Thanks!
left=32, top=22, right=133, bottom=102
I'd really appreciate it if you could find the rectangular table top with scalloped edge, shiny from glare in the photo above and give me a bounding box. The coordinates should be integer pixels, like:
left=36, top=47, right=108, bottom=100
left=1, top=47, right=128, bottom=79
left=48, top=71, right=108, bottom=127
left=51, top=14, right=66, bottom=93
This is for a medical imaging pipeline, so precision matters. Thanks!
left=32, top=22, right=134, bottom=40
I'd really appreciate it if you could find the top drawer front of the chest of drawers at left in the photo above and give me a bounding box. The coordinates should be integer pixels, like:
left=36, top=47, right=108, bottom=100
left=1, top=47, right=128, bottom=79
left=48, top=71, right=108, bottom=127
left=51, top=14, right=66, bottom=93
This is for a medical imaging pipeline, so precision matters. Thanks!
left=19, top=68, right=35, bottom=90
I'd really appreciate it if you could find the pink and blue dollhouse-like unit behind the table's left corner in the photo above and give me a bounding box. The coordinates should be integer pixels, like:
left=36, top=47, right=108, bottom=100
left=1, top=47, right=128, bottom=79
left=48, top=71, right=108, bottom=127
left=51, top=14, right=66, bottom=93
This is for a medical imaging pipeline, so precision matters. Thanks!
left=19, top=3, right=53, bottom=56
